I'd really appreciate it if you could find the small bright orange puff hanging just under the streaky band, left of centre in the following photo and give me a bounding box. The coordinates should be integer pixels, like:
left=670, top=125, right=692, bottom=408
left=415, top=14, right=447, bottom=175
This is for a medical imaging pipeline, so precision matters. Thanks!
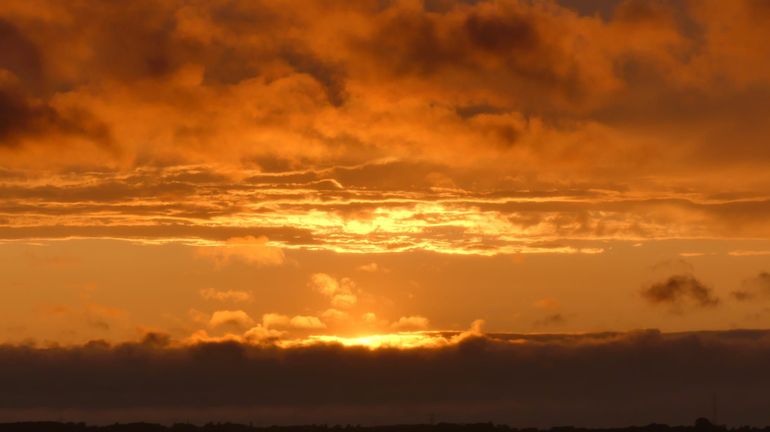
left=198, top=236, right=285, bottom=266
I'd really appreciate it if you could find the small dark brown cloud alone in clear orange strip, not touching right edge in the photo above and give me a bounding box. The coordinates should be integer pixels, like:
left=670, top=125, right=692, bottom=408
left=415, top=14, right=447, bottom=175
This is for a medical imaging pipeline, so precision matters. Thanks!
left=642, top=274, right=720, bottom=307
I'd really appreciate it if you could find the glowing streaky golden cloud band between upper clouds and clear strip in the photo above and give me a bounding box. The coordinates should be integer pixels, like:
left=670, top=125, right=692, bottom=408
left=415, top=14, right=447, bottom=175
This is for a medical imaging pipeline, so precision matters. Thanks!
left=0, top=161, right=770, bottom=256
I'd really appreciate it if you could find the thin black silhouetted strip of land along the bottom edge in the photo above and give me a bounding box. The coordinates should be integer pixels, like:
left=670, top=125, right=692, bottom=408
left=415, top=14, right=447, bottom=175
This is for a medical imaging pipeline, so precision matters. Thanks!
left=0, top=418, right=756, bottom=432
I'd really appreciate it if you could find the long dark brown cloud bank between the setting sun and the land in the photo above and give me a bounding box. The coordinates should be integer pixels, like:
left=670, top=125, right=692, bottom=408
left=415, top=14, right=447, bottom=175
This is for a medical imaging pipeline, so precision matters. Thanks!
left=0, top=331, right=770, bottom=426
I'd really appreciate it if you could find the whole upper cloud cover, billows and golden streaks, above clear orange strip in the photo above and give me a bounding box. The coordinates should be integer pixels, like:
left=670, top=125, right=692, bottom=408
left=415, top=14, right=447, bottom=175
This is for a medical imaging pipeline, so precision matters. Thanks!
left=0, top=0, right=770, bottom=255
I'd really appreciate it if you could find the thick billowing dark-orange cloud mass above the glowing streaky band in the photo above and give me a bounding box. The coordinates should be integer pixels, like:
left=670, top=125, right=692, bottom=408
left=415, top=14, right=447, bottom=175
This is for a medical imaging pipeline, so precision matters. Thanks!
left=0, top=0, right=770, bottom=178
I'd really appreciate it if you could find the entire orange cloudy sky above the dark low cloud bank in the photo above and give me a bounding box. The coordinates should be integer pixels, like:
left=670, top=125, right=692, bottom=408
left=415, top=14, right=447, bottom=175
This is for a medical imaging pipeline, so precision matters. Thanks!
left=0, top=0, right=770, bottom=343
